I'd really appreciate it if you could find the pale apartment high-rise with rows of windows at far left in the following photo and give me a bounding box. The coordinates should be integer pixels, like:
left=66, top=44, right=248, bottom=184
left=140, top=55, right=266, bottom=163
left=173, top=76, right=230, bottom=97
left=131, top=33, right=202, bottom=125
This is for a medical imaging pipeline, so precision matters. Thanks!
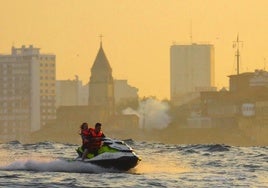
left=0, top=45, right=56, bottom=140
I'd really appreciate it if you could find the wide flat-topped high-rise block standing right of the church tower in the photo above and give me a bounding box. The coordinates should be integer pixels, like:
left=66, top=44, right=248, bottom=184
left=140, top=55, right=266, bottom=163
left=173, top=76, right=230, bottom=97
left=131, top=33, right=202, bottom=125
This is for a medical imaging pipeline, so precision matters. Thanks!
left=170, top=44, right=216, bottom=103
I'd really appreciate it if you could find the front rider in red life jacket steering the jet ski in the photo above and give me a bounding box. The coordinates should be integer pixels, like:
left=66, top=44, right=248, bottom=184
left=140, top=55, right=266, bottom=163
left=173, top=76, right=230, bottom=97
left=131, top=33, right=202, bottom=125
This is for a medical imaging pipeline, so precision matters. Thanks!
left=88, top=123, right=105, bottom=155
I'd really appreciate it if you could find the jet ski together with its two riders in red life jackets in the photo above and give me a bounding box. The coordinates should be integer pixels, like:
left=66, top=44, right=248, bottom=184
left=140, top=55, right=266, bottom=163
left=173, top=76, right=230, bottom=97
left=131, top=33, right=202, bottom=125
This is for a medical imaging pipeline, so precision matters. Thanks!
left=75, top=123, right=141, bottom=170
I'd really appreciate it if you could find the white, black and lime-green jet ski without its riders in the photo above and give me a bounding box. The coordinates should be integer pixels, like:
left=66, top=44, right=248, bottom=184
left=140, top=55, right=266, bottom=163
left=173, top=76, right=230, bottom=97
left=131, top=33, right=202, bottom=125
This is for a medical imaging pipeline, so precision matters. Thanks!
left=75, top=137, right=141, bottom=171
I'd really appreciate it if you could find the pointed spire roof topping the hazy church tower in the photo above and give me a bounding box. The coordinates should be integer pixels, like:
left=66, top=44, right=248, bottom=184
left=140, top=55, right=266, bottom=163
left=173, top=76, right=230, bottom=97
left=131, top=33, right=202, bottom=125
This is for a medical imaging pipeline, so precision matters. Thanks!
left=92, top=42, right=112, bottom=70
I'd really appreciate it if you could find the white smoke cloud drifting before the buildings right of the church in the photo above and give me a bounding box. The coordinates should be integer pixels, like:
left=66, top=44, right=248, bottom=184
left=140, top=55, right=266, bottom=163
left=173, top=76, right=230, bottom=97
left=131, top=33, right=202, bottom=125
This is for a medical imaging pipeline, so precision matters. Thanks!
left=123, top=98, right=171, bottom=130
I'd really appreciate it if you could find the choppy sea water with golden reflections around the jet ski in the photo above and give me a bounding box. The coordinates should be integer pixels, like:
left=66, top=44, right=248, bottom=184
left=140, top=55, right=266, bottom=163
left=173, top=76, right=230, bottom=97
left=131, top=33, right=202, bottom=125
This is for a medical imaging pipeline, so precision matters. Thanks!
left=0, top=140, right=268, bottom=187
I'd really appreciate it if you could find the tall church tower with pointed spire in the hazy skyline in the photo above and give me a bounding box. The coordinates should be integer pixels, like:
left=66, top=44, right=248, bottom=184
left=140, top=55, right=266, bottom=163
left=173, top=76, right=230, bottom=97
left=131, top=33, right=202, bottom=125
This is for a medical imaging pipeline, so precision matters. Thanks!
left=88, top=41, right=115, bottom=116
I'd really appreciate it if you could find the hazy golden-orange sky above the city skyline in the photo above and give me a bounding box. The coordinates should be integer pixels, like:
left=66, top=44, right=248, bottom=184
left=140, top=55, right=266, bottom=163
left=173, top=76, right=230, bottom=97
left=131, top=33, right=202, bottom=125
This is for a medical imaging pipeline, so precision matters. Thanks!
left=0, top=0, right=268, bottom=99
